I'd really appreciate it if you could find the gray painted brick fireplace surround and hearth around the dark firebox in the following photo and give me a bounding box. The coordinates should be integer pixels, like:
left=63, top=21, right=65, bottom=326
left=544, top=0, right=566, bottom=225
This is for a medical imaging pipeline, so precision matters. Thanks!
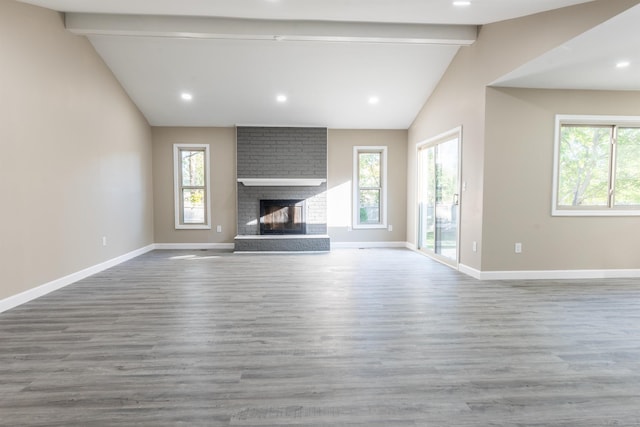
left=235, top=126, right=330, bottom=251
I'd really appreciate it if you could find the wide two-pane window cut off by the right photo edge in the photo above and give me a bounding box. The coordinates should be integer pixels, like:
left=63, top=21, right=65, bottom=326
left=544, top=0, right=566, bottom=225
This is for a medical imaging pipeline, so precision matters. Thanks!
left=552, top=115, right=640, bottom=216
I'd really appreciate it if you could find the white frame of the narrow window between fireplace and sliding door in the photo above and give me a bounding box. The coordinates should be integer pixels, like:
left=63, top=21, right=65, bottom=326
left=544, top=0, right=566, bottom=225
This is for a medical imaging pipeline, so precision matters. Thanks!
left=351, top=145, right=388, bottom=230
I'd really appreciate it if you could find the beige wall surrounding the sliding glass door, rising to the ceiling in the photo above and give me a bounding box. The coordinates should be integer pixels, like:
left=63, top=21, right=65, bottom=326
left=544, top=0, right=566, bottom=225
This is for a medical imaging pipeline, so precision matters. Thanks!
left=406, top=0, right=638, bottom=270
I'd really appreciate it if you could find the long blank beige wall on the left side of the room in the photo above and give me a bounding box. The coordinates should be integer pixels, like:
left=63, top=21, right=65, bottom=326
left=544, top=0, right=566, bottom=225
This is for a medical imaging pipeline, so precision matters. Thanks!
left=0, top=0, right=153, bottom=299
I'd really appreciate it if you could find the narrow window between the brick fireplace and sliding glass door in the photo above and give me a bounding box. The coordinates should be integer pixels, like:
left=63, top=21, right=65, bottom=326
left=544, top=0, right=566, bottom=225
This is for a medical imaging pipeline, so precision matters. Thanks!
left=353, top=146, right=387, bottom=228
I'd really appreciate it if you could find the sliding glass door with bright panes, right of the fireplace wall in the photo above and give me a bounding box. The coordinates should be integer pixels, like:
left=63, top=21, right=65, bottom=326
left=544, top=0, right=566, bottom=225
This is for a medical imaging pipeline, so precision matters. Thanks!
left=418, top=130, right=460, bottom=265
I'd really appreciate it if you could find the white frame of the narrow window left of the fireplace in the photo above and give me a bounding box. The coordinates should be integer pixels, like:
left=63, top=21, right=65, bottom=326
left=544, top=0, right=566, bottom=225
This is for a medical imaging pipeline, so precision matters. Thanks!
left=173, top=144, right=211, bottom=230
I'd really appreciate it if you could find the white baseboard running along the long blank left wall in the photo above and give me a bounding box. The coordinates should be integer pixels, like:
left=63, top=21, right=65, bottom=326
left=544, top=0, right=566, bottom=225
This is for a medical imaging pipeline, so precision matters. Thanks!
left=0, top=245, right=155, bottom=313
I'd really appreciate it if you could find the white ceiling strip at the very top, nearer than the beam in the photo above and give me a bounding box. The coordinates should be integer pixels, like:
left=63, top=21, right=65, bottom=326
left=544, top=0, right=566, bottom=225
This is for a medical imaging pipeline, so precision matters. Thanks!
left=15, top=0, right=590, bottom=25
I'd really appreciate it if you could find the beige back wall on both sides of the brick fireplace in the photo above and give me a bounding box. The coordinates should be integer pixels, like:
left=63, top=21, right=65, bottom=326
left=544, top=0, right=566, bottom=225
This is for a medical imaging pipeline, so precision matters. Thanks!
left=152, top=127, right=407, bottom=244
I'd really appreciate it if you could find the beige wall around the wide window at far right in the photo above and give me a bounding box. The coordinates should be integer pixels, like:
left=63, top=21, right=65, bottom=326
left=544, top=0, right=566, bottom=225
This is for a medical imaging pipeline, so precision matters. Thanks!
left=482, top=88, right=640, bottom=271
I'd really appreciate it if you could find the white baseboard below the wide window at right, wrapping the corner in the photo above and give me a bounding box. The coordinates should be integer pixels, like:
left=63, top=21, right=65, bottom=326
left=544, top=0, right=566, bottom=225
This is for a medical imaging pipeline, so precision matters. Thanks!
left=458, top=264, right=640, bottom=280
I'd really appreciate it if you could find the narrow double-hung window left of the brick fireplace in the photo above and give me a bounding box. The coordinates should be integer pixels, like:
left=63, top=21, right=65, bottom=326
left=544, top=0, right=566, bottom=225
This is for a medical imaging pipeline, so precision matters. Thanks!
left=173, top=144, right=211, bottom=229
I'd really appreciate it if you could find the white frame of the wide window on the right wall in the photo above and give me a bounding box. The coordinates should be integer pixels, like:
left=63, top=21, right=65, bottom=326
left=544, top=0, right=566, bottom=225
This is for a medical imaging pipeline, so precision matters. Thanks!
left=551, top=114, right=640, bottom=216
